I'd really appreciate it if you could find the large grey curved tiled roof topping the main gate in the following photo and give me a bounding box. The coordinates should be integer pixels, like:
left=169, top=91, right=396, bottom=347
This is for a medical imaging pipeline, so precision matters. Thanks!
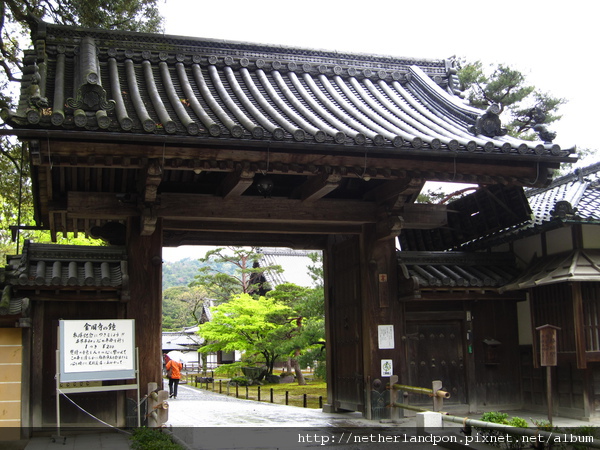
left=4, top=24, right=571, bottom=160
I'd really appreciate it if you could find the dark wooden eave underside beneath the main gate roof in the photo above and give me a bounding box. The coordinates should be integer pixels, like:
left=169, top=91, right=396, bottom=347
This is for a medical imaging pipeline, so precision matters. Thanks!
left=29, top=139, right=559, bottom=248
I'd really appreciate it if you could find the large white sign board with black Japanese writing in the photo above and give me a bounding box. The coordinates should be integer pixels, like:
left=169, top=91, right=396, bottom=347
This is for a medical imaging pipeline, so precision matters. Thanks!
left=59, top=319, right=136, bottom=382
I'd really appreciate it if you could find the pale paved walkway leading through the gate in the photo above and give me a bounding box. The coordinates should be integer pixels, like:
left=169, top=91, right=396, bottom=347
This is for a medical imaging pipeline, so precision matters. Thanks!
left=21, top=385, right=590, bottom=450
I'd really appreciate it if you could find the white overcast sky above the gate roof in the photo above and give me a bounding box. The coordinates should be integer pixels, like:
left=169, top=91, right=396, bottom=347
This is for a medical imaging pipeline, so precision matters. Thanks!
left=161, top=0, right=600, bottom=270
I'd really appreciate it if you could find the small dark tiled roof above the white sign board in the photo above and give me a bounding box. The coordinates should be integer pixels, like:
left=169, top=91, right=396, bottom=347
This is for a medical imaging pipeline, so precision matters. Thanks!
left=5, top=241, right=128, bottom=289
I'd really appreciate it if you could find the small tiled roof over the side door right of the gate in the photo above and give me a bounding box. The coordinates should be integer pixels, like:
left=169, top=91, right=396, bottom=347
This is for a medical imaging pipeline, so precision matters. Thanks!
left=397, top=252, right=519, bottom=289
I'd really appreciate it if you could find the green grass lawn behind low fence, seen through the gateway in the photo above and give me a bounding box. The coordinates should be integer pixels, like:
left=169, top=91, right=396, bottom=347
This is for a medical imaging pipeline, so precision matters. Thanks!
left=188, top=379, right=327, bottom=409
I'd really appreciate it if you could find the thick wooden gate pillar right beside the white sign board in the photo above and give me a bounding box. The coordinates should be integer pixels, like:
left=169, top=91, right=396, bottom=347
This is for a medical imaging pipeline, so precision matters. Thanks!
left=127, top=218, right=162, bottom=396
